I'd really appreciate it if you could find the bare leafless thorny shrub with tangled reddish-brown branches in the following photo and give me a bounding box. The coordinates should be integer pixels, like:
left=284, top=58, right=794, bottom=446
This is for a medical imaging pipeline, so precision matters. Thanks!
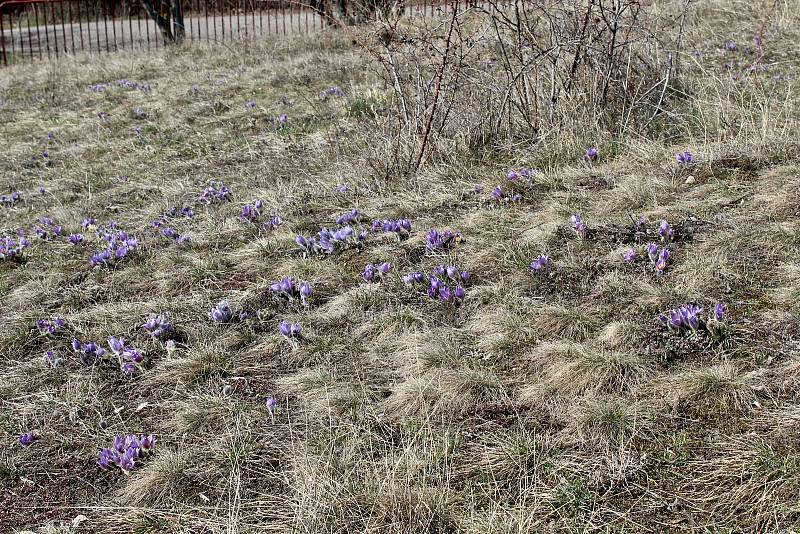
left=363, top=0, right=686, bottom=174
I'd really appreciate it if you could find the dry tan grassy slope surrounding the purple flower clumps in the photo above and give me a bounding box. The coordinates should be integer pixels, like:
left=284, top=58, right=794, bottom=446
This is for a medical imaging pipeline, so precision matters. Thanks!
left=0, top=4, right=800, bottom=532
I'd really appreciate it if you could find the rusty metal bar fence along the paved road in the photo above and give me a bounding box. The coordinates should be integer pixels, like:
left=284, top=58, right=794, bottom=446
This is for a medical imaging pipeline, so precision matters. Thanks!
left=0, top=0, right=447, bottom=65
